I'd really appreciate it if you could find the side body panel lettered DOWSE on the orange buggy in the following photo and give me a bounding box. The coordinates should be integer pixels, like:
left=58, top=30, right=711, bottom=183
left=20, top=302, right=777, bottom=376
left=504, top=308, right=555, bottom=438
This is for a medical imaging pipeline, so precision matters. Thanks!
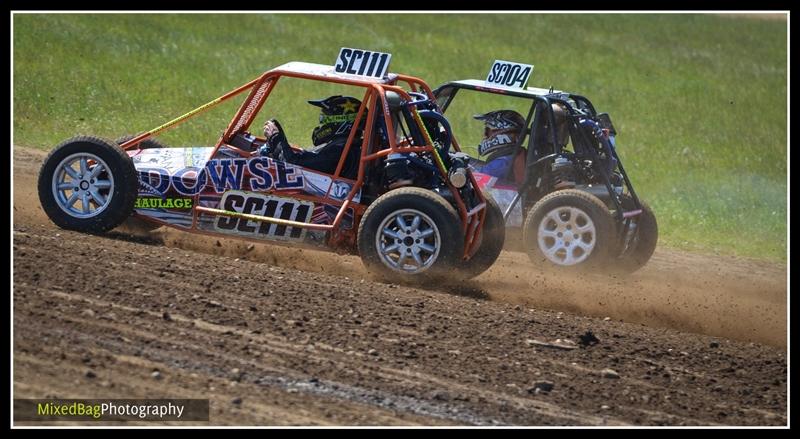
left=129, top=147, right=362, bottom=251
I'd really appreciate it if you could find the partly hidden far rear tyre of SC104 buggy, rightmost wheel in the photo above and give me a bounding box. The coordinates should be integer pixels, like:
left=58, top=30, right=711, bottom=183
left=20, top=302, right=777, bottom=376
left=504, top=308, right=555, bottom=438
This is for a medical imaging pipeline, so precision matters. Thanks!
left=615, top=196, right=658, bottom=273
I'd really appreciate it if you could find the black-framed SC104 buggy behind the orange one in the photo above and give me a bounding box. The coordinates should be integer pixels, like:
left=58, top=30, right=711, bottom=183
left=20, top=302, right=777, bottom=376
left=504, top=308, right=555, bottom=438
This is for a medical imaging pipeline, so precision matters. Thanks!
left=434, top=80, right=658, bottom=273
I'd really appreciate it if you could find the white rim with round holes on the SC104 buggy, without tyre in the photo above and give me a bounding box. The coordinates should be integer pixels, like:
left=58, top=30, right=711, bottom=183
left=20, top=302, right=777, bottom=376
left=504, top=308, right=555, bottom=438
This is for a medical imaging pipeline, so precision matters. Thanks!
left=537, top=206, right=597, bottom=266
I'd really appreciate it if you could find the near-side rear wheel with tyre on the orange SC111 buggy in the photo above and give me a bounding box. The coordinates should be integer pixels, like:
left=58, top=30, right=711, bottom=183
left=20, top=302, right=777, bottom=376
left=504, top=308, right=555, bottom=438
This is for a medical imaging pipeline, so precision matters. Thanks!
left=358, top=187, right=464, bottom=283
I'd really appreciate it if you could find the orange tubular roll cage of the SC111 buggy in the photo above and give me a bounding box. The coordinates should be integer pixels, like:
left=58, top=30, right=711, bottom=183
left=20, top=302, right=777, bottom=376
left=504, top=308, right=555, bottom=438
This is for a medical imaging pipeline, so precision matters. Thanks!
left=114, top=62, right=486, bottom=259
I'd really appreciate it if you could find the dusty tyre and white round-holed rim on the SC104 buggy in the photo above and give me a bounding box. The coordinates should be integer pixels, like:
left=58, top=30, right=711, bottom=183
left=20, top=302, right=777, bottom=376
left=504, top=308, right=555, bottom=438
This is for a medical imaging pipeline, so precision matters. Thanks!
left=523, top=189, right=617, bottom=270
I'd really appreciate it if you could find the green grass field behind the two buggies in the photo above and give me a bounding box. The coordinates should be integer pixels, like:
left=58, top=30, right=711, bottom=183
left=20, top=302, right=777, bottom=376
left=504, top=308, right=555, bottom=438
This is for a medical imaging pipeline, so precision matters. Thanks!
left=13, top=14, right=787, bottom=260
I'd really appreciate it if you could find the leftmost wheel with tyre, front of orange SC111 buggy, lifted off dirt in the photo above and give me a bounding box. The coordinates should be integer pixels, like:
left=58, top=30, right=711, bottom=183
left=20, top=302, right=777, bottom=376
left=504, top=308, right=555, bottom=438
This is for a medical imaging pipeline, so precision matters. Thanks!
left=38, top=136, right=138, bottom=233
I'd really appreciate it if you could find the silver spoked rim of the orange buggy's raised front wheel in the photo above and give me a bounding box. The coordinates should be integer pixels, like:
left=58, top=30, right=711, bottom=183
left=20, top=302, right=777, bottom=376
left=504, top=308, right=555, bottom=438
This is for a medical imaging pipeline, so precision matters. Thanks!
left=52, top=153, right=114, bottom=218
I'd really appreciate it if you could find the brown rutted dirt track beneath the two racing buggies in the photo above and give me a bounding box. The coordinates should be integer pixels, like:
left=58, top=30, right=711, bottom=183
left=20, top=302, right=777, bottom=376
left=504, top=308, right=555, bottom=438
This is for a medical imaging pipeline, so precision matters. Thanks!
left=13, top=148, right=787, bottom=425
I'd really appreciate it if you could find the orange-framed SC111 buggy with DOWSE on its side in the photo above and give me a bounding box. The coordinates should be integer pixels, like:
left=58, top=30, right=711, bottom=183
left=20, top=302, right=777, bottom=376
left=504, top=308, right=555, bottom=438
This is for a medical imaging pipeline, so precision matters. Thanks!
left=39, top=56, right=505, bottom=282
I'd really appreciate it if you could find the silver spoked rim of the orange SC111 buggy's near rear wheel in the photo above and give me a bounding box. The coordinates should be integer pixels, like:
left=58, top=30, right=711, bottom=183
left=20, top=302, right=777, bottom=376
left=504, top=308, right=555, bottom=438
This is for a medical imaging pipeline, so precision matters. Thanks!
left=375, top=209, right=442, bottom=274
